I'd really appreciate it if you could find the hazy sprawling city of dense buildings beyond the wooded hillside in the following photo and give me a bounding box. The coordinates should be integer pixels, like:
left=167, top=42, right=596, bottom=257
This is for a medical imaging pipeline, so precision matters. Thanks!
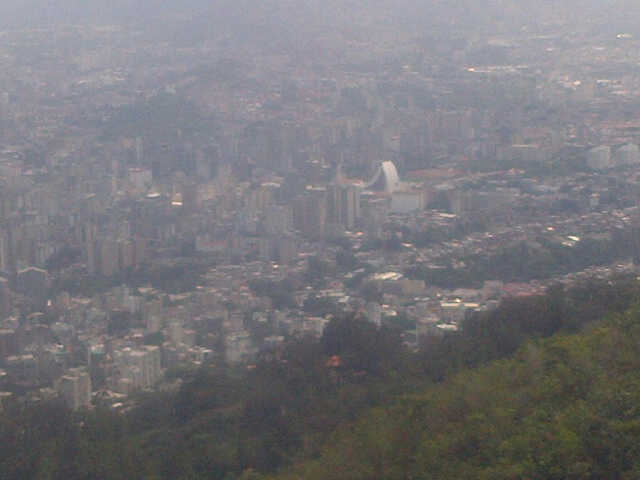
left=0, top=2, right=640, bottom=411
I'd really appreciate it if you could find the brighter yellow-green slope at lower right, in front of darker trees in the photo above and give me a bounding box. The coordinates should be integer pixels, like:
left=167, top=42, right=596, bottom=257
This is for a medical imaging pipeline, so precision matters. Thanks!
left=274, top=307, right=640, bottom=480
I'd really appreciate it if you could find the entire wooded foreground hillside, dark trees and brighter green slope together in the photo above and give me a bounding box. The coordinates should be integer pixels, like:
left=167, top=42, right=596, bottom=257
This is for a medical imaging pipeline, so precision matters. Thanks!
left=0, top=278, right=640, bottom=480
